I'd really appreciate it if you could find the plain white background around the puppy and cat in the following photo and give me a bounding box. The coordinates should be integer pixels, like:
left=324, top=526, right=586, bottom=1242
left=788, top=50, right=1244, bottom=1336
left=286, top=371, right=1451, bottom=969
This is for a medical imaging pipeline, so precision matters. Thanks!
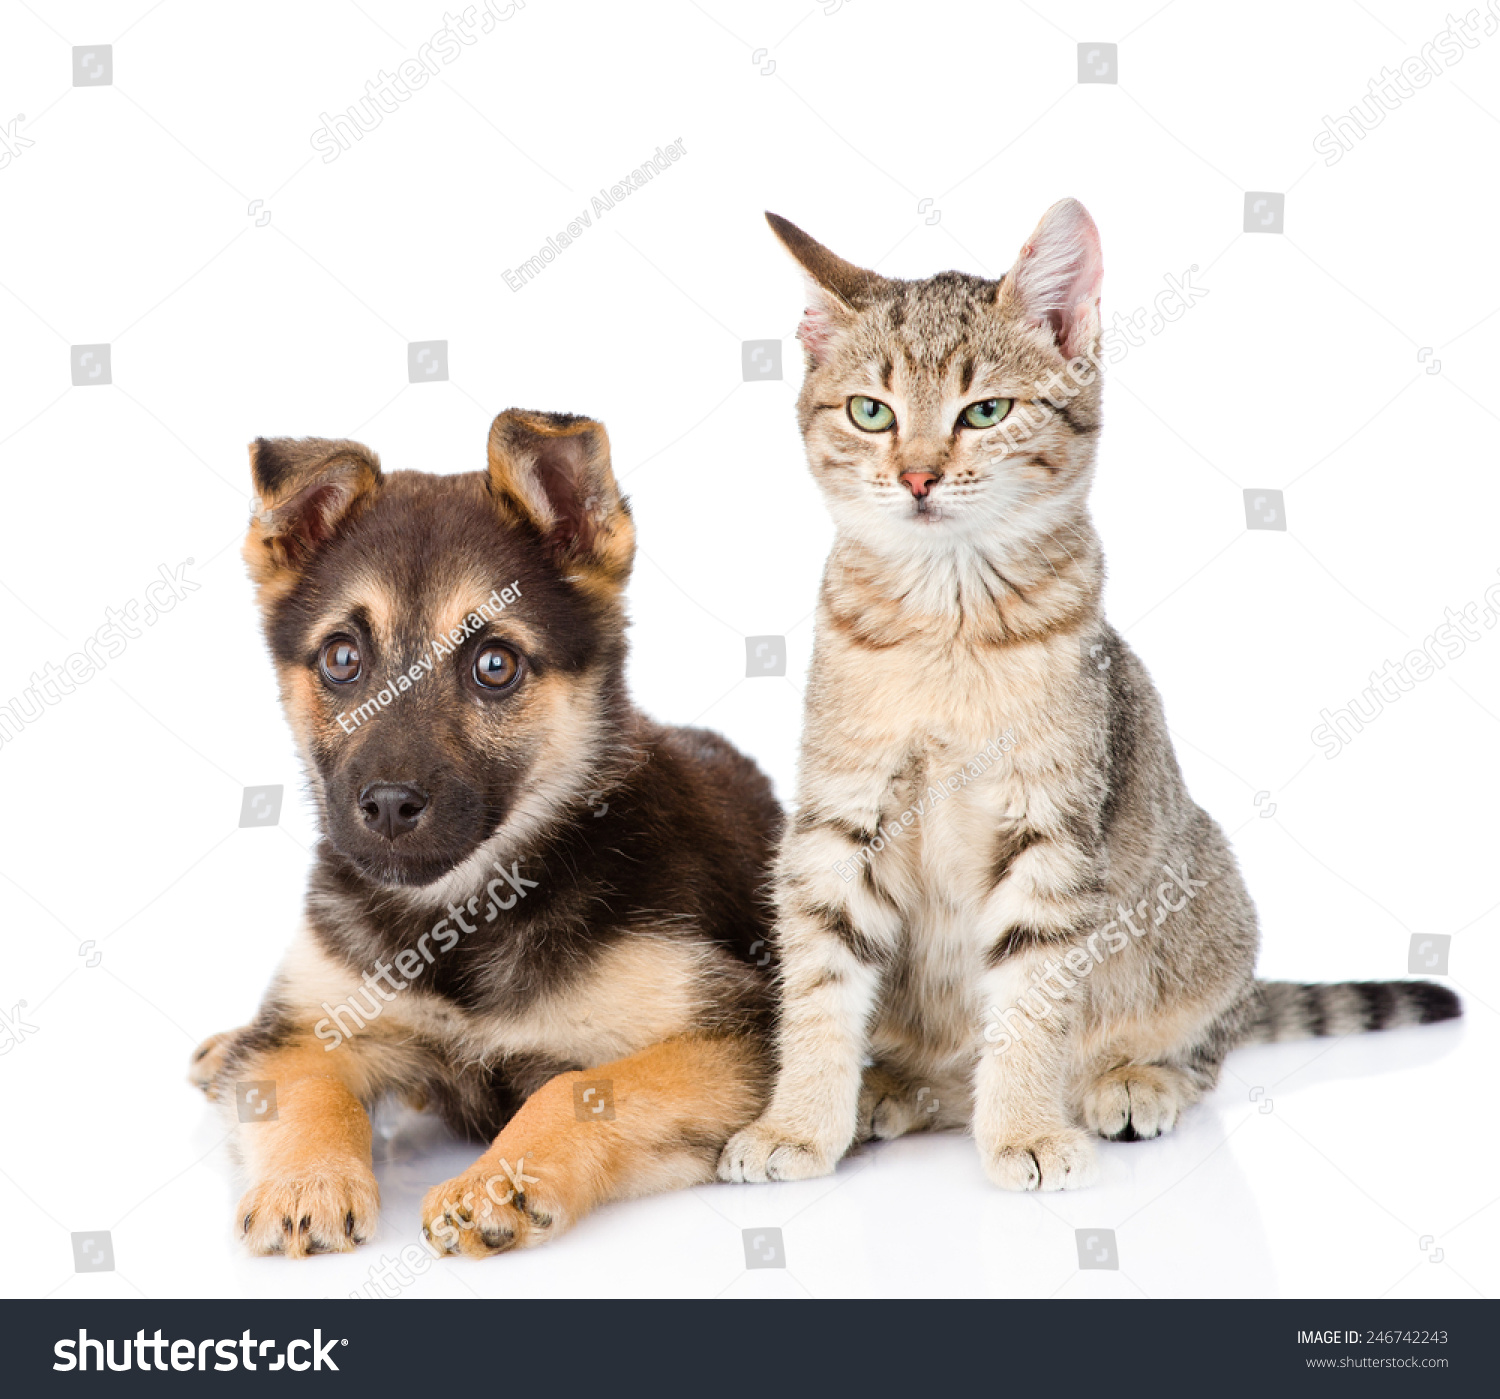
left=0, top=0, right=1500, bottom=1297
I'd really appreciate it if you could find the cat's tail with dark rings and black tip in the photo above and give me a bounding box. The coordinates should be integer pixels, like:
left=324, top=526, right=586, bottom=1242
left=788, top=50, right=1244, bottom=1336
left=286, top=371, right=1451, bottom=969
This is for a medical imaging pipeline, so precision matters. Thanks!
left=1239, top=981, right=1464, bottom=1044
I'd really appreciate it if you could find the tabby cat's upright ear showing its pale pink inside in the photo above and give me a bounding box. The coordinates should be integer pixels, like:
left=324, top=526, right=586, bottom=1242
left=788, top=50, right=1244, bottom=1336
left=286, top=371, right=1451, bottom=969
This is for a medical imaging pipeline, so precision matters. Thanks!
left=1001, top=199, right=1104, bottom=360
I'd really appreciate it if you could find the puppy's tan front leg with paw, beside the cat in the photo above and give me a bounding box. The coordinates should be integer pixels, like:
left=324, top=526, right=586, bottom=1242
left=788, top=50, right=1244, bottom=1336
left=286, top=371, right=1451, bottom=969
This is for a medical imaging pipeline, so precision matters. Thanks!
left=422, top=1039, right=764, bottom=1258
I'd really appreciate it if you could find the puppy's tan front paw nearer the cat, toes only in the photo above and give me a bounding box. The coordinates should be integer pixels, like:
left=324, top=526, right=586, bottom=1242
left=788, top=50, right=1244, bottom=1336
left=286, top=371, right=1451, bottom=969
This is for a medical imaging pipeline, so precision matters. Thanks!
left=422, top=1158, right=570, bottom=1258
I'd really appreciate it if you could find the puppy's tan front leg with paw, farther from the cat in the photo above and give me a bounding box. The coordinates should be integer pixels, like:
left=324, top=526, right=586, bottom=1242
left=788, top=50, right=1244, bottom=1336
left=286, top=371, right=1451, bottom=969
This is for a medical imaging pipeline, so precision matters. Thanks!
left=236, top=1042, right=380, bottom=1258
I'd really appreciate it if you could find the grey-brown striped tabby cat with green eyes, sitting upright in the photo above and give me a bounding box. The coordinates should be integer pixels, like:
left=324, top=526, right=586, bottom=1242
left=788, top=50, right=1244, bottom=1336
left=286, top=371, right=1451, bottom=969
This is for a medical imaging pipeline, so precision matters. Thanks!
left=720, top=199, right=1460, bottom=1189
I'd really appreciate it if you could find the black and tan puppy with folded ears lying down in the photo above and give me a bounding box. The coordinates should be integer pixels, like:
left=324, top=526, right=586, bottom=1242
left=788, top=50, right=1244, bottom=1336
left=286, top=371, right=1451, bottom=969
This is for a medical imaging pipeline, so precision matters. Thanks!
left=192, top=409, right=782, bottom=1257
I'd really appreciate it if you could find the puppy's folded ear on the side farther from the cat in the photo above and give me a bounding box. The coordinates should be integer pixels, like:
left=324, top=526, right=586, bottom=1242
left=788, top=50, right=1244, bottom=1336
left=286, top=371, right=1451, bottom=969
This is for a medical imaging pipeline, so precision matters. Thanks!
left=245, top=438, right=381, bottom=585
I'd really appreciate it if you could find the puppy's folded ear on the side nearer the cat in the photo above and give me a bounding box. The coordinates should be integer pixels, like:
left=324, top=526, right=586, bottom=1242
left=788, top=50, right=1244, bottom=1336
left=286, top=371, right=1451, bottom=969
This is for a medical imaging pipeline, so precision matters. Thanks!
left=489, top=408, right=636, bottom=588
